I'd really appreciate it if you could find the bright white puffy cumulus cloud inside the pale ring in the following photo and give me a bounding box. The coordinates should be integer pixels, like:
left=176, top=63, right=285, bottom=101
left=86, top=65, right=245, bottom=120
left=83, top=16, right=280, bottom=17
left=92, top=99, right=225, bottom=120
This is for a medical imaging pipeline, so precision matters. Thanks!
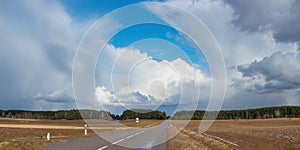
left=95, top=45, right=210, bottom=108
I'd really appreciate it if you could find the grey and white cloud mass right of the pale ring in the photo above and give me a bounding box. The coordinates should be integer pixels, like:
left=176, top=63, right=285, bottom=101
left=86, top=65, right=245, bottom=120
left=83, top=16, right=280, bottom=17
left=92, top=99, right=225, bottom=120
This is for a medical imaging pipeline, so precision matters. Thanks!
left=157, top=0, right=300, bottom=109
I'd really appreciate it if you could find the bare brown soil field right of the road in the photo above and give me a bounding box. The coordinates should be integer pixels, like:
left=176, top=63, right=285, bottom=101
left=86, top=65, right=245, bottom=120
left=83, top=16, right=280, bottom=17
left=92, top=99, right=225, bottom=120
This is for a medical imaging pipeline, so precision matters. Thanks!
left=168, top=118, right=300, bottom=150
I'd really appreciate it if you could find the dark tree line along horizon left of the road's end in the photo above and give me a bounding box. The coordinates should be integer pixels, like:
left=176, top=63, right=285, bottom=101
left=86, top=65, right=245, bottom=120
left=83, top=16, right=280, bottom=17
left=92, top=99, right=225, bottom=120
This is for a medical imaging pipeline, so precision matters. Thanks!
left=0, top=109, right=166, bottom=120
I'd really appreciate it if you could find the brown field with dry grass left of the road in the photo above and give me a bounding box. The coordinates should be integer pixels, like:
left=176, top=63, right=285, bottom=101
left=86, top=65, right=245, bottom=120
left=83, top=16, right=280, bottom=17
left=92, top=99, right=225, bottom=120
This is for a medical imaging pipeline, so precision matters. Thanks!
left=0, top=128, right=95, bottom=150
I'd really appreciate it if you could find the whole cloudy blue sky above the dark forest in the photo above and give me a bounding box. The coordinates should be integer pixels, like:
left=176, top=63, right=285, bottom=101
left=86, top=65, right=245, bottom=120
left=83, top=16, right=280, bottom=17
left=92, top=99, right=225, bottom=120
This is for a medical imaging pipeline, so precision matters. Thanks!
left=0, top=0, right=300, bottom=114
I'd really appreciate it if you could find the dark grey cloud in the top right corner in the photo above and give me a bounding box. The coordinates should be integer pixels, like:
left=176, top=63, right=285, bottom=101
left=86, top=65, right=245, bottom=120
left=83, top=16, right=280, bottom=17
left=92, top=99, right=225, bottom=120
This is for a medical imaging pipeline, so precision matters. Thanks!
left=227, top=0, right=300, bottom=42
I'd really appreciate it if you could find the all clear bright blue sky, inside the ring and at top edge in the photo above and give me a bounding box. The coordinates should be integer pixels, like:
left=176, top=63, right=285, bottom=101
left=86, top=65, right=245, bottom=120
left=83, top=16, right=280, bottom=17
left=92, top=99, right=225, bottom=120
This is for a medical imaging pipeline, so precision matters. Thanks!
left=61, top=0, right=209, bottom=74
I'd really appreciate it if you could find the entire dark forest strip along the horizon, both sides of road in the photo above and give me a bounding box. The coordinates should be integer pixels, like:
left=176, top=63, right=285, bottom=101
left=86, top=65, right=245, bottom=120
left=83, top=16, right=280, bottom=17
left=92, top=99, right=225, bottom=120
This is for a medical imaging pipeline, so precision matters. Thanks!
left=0, top=106, right=300, bottom=120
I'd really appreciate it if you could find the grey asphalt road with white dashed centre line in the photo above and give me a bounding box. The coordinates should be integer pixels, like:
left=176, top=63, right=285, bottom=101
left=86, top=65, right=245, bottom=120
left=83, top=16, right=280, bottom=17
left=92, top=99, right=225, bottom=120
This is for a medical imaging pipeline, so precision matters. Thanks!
left=44, top=122, right=168, bottom=150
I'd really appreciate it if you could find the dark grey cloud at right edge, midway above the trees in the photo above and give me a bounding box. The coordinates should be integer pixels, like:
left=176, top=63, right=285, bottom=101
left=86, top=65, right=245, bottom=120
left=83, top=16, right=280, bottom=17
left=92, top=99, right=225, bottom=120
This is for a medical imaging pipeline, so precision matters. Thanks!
left=235, top=52, right=300, bottom=93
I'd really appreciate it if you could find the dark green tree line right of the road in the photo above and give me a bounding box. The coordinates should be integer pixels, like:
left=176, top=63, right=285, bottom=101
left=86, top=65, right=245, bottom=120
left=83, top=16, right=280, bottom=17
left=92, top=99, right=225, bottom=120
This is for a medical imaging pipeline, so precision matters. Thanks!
left=172, top=106, right=300, bottom=120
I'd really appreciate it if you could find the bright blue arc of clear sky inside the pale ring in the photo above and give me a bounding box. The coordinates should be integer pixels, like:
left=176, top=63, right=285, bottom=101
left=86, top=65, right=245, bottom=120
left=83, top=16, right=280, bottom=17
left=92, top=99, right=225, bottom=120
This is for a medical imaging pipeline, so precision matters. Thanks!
left=109, top=24, right=209, bottom=74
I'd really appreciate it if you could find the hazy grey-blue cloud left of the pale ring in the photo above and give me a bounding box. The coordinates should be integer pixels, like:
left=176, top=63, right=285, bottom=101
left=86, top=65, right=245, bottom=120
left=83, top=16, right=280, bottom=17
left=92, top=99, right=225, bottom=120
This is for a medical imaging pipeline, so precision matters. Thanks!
left=0, top=0, right=73, bottom=109
